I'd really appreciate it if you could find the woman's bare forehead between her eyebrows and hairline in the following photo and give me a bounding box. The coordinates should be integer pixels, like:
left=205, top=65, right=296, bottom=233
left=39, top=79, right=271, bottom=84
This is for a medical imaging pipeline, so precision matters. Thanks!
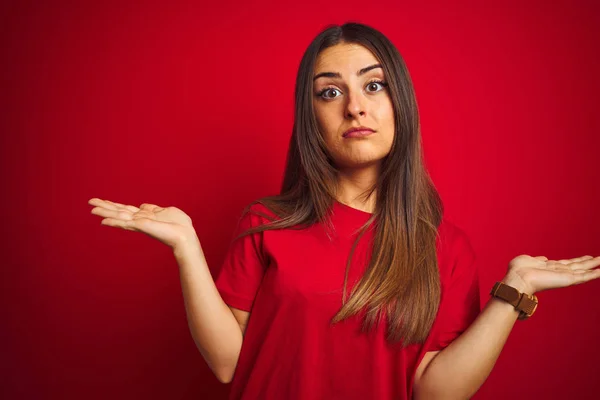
left=315, top=43, right=378, bottom=75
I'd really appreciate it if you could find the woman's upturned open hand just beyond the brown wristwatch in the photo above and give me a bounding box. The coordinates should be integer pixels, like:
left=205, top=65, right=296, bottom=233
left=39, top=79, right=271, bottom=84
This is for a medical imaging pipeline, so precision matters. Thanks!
left=502, top=255, right=600, bottom=294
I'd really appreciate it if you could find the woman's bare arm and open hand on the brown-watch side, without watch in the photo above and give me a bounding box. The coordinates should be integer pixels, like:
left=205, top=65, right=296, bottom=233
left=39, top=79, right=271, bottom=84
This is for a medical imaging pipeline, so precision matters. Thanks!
left=413, top=255, right=600, bottom=399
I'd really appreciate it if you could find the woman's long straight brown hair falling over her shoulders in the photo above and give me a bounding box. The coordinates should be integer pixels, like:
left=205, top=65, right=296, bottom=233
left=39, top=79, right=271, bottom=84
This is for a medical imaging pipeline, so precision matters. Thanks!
left=240, top=22, right=443, bottom=346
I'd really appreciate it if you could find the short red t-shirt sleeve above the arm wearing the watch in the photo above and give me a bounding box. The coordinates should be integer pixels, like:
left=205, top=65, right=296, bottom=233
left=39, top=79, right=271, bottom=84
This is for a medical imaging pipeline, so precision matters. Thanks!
left=427, top=230, right=481, bottom=351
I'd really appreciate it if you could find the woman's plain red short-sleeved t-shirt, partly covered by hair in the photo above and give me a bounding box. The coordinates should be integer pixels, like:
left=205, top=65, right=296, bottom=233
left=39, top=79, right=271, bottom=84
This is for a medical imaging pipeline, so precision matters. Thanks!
left=215, top=202, right=480, bottom=400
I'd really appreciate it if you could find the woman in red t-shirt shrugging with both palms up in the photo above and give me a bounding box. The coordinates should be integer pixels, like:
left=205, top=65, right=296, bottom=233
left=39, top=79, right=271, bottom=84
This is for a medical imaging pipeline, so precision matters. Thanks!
left=89, top=23, right=600, bottom=399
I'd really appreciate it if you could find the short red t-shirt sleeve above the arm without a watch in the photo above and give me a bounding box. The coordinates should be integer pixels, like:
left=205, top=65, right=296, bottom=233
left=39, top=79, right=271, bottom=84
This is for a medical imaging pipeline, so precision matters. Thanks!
left=215, top=206, right=265, bottom=311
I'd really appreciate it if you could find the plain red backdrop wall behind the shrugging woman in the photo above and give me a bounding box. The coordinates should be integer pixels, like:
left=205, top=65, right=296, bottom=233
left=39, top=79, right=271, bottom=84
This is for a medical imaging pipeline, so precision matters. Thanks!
left=0, top=0, right=600, bottom=399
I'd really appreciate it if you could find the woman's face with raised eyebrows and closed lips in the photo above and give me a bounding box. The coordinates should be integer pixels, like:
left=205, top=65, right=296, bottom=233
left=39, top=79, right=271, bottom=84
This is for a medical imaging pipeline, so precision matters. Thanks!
left=313, top=43, right=394, bottom=169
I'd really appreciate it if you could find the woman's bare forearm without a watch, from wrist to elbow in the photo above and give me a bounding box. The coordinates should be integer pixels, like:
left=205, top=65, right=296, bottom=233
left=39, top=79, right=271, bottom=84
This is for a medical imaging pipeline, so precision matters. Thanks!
left=174, top=239, right=243, bottom=382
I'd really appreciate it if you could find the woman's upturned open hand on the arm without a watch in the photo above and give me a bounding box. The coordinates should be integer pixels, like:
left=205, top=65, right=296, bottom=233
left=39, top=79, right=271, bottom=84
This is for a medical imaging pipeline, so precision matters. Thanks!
left=88, top=198, right=197, bottom=250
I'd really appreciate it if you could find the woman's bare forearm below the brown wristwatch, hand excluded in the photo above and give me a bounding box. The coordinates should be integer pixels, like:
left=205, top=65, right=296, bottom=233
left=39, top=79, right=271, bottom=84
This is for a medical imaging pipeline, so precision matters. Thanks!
left=414, top=278, right=522, bottom=399
